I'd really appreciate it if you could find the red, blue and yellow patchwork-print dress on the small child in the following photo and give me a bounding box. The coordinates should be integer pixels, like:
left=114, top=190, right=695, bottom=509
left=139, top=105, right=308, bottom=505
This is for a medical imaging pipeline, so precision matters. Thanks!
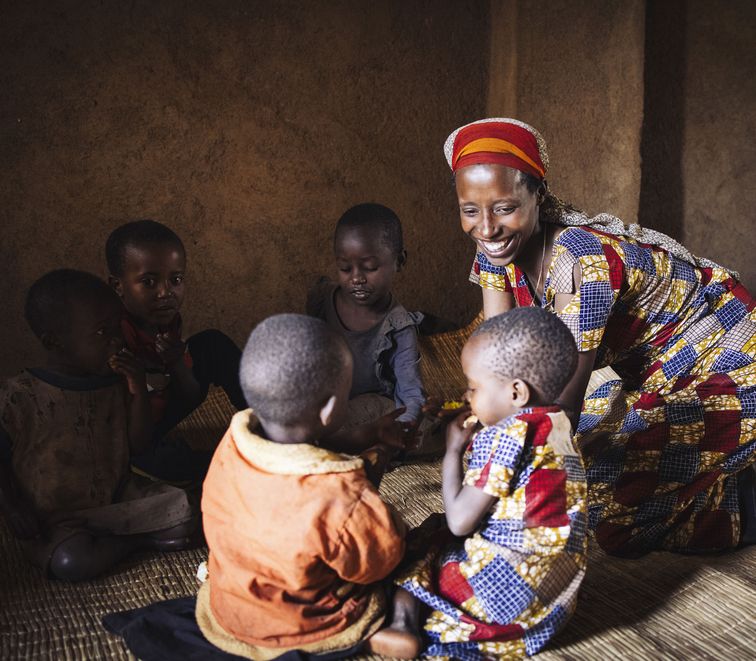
left=396, top=407, right=587, bottom=660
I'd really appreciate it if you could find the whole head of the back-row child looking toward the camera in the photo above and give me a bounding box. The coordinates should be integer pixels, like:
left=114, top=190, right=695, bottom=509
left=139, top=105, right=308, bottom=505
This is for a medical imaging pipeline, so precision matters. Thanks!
left=105, top=220, right=186, bottom=329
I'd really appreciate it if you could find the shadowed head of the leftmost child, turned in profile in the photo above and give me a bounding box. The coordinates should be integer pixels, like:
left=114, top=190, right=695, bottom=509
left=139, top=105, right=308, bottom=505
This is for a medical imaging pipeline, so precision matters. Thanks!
left=24, top=269, right=123, bottom=376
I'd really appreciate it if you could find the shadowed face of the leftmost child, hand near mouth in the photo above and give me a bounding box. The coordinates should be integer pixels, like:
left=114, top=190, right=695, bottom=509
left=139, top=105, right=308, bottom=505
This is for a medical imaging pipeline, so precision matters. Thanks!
left=52, top=293, right=123, bottom=376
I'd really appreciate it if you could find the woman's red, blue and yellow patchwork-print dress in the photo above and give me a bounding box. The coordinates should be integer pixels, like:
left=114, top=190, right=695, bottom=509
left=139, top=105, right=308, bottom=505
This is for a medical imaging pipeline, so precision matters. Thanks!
left=470, top=227, right=756, bottom=556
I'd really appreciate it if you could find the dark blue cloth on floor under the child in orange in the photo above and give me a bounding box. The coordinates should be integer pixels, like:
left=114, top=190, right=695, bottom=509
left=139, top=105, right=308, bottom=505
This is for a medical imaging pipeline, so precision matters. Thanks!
left=102, top=597, right=362, bottom=661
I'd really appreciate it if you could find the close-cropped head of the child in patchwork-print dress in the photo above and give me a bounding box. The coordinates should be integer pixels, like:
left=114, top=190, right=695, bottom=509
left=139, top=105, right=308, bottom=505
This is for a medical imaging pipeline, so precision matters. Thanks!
left=462, top=307, right=577, bottom=425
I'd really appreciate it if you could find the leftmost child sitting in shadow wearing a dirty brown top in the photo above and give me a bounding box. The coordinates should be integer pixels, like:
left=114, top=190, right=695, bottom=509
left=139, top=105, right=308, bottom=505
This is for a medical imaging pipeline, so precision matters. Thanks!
left=0, top=270, right=199, bottom=581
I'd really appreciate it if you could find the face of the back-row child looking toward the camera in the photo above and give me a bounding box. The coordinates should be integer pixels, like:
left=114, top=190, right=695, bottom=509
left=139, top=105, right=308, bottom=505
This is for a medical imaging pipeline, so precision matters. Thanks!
left=111, top=243, right=186, bottom=330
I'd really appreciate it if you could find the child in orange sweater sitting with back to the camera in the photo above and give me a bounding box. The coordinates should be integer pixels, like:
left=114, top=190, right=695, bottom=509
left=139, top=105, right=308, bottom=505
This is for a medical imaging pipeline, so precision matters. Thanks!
left=196, top=314, right=405, bottom=659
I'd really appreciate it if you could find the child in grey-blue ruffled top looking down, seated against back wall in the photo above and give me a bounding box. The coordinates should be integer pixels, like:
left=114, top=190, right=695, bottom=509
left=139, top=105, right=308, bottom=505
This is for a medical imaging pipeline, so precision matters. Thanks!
left=307, top=204, right=425, bottom=427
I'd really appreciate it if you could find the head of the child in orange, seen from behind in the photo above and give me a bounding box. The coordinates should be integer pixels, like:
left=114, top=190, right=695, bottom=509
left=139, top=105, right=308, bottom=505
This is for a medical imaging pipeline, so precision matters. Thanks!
left=239, top=314, right=352, bottom=440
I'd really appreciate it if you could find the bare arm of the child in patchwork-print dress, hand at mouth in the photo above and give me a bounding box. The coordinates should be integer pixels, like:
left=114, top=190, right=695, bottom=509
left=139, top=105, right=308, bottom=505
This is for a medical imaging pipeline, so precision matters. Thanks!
left=441, top=411, right=496, bottom=537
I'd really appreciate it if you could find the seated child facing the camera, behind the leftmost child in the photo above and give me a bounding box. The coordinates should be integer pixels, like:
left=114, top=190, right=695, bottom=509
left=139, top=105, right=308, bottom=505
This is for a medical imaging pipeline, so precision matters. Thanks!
left=105, top=220, right=246, bottom=482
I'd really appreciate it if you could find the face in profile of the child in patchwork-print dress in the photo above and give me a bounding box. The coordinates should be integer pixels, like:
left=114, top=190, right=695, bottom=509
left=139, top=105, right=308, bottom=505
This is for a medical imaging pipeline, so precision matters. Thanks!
left=462, top=335, right=520, bottom=425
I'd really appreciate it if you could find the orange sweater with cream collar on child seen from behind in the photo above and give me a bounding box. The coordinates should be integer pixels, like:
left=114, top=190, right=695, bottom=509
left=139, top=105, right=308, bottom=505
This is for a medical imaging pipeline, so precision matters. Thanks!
left=202, top=411, right=404, bottom=648
